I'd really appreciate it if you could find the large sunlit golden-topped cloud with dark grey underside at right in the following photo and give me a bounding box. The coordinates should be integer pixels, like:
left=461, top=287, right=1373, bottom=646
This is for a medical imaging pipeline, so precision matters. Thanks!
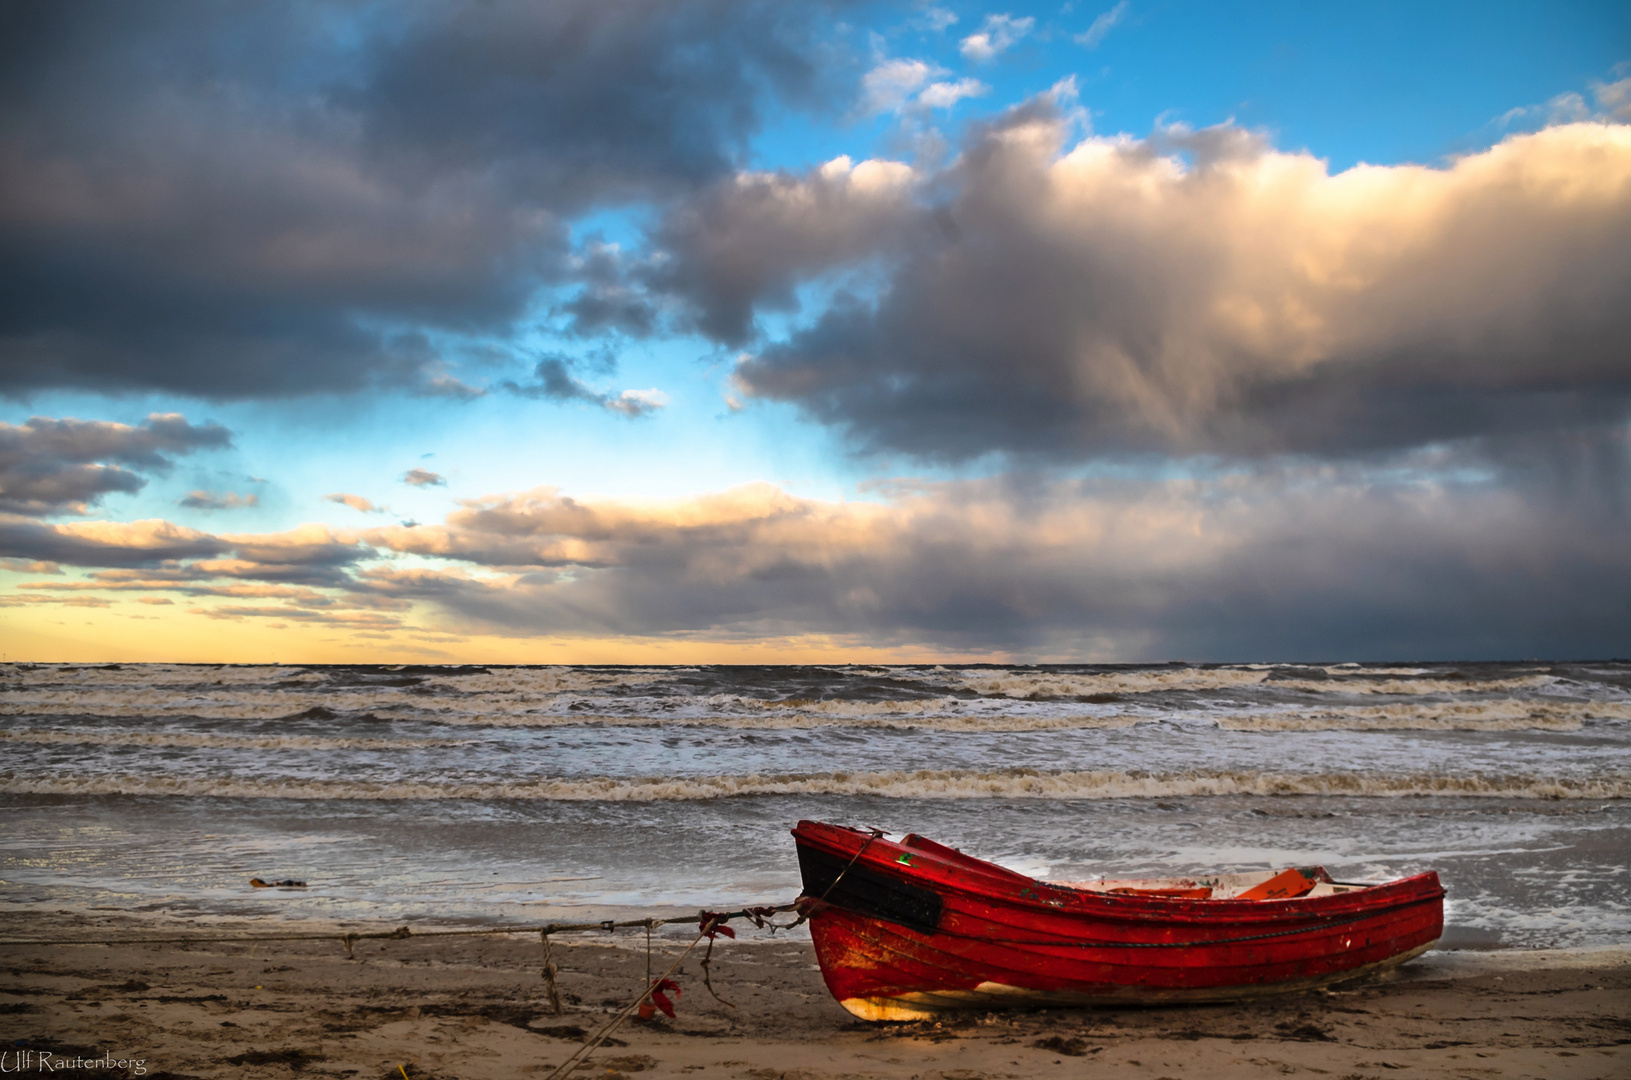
left=727, top=106, right=1631, bottom=460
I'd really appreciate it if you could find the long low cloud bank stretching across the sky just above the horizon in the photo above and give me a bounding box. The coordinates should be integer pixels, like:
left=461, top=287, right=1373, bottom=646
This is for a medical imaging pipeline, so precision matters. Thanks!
left=0, top=427, right=1631, bottom=661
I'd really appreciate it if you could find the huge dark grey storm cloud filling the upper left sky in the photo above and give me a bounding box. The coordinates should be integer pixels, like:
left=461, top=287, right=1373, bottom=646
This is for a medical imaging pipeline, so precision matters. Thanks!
left=0, top=0, right=827, bottom=396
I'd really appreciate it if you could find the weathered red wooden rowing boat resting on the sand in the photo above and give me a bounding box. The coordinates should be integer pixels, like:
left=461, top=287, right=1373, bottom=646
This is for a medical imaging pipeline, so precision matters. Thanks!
left=793, top=821, right=1443, bottom=1020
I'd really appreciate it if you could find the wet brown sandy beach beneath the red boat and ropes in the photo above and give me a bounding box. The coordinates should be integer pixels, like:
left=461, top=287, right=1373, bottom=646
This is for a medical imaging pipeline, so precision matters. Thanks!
left=0, top=912, right=1631, bottom=1080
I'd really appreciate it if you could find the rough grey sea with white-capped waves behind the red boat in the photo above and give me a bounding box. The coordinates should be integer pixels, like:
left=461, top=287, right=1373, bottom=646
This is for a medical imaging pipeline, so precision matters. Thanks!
left=0, top=661, right=1631, bottom=949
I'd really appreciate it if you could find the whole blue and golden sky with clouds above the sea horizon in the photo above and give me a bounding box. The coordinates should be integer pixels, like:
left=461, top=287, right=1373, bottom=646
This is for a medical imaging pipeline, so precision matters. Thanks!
left=0, top=0, right=1631, bottom=664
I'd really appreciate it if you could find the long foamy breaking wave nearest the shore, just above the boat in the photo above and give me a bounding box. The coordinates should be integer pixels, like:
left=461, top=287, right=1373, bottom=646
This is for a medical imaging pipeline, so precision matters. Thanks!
left=0, top=768, right=1631, bottom=803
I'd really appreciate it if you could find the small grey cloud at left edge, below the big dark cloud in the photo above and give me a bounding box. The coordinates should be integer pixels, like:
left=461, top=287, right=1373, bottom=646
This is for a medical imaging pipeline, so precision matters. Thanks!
left=0, top=413, right=232, bottom=516
